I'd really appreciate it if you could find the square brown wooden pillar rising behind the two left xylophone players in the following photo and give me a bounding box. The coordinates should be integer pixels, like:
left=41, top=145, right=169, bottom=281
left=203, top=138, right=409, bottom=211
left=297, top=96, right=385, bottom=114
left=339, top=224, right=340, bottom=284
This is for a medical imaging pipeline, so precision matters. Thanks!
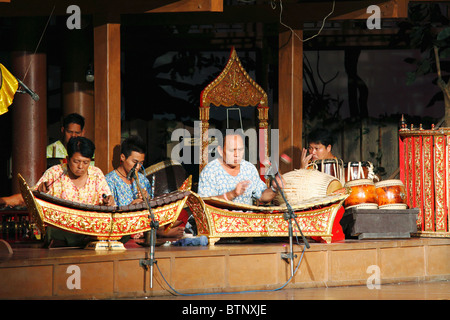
left=94, top=16, right=121, bottom=174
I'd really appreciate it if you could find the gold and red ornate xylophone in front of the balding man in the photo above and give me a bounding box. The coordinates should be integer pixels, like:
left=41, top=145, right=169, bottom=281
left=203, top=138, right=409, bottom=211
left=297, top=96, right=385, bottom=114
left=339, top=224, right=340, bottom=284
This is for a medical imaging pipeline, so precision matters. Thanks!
left=186, top=188, right=351, bottom=245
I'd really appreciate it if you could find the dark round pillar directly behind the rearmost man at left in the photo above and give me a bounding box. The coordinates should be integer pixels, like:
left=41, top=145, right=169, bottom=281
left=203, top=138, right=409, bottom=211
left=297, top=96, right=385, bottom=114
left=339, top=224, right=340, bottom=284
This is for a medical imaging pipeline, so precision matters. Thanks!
left=62, top=23, right=95, bottom=141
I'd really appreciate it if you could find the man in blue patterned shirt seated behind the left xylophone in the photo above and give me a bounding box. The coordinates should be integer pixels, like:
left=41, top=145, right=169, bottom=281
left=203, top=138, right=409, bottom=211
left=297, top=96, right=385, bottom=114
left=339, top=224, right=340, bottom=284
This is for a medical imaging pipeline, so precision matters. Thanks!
left=106, top=136, right=187, bottom=239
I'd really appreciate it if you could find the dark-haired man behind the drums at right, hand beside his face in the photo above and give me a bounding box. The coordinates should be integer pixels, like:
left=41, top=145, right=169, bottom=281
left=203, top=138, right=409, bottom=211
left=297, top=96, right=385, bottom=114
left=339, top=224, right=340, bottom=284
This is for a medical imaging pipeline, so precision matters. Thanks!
left=300, top=129, right=336, bottom=169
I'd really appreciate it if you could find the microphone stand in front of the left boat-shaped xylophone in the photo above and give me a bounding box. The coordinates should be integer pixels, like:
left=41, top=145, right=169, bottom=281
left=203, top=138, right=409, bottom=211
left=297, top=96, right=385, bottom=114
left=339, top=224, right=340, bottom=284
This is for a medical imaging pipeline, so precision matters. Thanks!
left=130, top=169, right=159, bottom=289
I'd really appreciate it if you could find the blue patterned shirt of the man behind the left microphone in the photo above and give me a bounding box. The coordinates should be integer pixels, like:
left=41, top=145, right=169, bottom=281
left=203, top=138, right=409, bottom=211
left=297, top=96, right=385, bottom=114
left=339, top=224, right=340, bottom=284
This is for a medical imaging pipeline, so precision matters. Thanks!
left=105, top=170, right=152, bottom=206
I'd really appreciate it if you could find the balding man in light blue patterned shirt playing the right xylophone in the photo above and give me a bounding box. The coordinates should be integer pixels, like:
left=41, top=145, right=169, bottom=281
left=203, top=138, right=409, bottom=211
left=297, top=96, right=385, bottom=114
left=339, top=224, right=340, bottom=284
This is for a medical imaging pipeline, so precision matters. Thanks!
left=198, top=130, right=281, bottom=205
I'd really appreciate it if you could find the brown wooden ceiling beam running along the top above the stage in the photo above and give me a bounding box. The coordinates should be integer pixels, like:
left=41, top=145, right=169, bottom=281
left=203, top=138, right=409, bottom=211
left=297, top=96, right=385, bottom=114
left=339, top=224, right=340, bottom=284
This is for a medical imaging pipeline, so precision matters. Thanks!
left=0, top=0, right=414, bottom=21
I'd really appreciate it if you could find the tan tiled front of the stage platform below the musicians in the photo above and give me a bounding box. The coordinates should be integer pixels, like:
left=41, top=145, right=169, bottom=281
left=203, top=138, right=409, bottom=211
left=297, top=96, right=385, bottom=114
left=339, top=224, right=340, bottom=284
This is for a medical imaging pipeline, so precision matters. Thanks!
left=0, top=238, right=450, bottom=299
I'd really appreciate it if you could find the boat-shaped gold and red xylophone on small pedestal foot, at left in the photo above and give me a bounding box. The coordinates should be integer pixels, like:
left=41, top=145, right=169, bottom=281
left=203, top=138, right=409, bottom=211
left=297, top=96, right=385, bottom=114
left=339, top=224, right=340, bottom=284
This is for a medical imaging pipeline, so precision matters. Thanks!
left=18, top=174, right=191, bottom=250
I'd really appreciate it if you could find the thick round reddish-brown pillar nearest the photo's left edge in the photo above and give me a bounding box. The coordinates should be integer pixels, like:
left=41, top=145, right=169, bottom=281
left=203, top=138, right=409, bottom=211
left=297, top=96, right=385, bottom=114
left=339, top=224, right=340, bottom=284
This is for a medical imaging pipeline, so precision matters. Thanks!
left=9, top=18, right=47, bottom=193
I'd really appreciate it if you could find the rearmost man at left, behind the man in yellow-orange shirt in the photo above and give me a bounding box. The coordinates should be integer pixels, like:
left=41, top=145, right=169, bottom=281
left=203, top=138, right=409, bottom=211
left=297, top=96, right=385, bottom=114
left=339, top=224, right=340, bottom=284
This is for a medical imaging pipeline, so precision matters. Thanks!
left=47, top=113, right=85, bottom=159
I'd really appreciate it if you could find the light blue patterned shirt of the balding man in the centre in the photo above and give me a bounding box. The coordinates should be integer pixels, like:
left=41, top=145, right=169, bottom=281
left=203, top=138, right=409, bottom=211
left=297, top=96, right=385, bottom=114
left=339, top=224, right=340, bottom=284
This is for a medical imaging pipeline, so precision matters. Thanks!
left=198, top=159, right=267, bottom=205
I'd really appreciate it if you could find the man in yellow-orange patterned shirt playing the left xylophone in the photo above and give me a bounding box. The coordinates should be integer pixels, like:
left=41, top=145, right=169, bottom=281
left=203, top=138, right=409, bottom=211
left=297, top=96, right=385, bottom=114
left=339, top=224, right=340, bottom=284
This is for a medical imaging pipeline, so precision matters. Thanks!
left=34, top=137, right=114, bottom=246
